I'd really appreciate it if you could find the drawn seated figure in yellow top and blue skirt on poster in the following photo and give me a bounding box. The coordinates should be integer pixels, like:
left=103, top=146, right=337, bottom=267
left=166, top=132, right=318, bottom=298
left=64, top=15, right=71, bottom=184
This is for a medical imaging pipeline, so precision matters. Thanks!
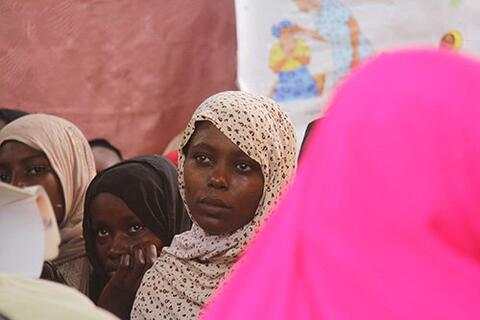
left=269, top=20, right=325, bottom=102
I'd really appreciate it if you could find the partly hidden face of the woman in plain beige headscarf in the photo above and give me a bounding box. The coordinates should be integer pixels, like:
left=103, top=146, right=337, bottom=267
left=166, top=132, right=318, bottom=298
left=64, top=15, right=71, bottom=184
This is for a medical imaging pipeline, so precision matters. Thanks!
left=0, top=140, right=65, bottom=224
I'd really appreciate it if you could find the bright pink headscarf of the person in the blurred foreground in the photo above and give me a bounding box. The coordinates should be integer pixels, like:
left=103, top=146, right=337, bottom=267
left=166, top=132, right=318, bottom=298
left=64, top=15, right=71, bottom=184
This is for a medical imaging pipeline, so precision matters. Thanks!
left=204, top=50, right=480, bottom=320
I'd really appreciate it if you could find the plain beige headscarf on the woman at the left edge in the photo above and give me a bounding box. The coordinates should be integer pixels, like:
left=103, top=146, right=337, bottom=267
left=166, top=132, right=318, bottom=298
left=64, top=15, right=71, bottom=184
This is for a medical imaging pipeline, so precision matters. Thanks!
left=0, top=114, right=95, bottom=287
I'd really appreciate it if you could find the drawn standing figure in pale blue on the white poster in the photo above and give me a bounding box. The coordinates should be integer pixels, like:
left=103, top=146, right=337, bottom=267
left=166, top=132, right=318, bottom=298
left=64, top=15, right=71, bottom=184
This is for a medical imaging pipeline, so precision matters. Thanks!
left=293, top=0, right=373, bottom=83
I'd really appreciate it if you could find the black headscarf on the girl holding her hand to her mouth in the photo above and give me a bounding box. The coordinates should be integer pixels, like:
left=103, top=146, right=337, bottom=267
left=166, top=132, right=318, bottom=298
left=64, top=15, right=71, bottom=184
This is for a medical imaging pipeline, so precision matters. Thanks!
left=83, top=156, right=191, bottom=300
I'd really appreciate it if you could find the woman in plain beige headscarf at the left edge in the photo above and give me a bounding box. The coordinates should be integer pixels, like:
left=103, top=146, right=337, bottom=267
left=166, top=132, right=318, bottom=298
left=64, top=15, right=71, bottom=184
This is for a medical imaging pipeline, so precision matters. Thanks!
left=0, top=114, right=95, bottom=293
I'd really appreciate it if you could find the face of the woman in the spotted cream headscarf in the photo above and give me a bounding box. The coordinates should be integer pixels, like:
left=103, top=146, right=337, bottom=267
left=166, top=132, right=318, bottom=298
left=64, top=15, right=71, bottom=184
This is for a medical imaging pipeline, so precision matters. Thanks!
left=184, top=121, right=264, bottom=235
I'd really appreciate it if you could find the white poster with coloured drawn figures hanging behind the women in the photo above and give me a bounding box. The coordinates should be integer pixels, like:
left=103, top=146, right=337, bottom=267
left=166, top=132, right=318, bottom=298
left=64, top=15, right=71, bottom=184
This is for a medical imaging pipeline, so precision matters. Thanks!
left=235, top=0, right=480, bottom=145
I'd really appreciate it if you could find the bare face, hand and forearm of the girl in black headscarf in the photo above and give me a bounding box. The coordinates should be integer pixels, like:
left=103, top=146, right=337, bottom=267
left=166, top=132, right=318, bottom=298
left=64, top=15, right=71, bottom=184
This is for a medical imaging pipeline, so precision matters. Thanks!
left=91, top=193, right=163, bottom=319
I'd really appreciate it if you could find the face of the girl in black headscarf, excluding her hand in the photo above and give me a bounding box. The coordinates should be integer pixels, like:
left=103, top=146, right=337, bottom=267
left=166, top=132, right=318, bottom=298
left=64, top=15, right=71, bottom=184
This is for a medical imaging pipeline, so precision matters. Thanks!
left=90, top=193, right=163, bottom=278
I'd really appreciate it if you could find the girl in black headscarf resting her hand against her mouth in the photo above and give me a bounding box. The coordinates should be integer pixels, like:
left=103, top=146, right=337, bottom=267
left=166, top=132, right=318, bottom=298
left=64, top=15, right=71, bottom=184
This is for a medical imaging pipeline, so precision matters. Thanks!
left=83, top=156, right=191, bottom=319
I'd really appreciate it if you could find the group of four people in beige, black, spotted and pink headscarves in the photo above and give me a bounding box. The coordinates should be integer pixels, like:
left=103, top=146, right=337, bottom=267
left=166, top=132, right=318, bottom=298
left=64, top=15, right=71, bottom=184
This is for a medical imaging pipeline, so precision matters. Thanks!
left=0, top=50, right=480, bottom=319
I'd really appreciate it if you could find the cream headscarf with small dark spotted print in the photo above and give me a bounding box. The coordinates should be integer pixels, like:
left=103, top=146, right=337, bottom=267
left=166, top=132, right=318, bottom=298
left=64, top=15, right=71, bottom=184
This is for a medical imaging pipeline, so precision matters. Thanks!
left=131, top=91, right=296, bottom=319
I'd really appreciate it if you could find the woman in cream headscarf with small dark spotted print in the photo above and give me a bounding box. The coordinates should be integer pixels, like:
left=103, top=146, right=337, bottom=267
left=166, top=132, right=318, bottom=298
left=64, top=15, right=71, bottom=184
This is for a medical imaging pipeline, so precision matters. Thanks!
left=131, top=91, right=296, bottom=319
